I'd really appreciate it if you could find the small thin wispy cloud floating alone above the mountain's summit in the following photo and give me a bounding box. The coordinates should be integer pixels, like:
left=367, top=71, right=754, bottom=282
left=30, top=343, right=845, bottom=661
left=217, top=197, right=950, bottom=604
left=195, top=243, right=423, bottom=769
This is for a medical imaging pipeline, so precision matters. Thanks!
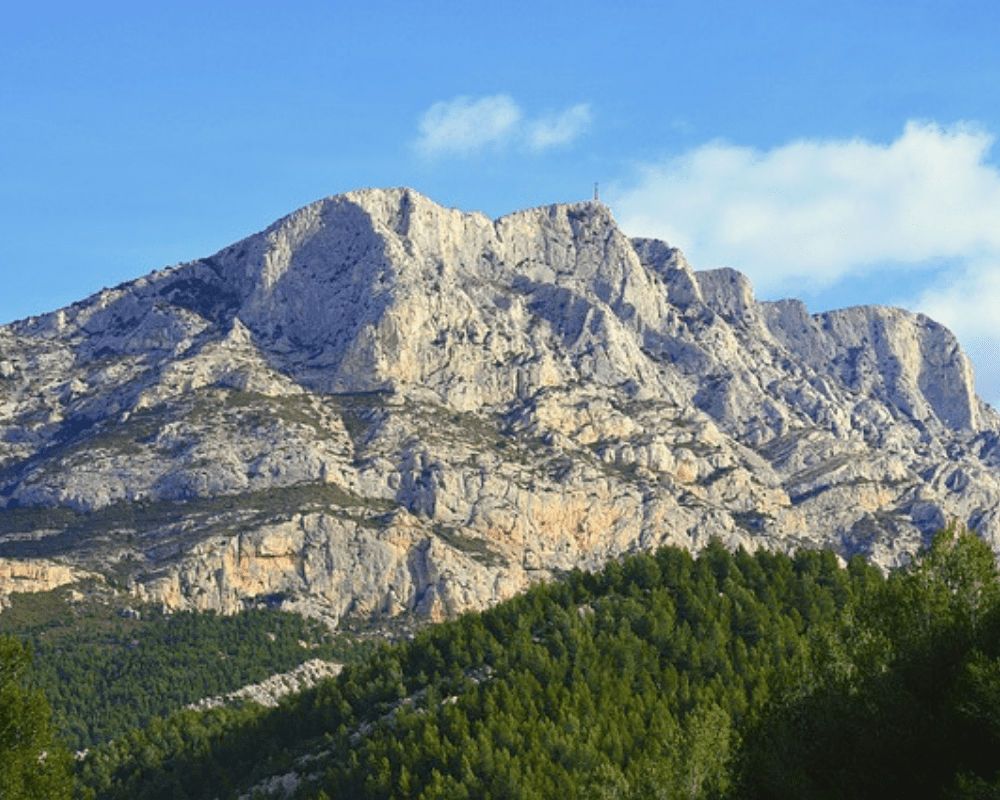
left=414, top=94, right=590, bottom=158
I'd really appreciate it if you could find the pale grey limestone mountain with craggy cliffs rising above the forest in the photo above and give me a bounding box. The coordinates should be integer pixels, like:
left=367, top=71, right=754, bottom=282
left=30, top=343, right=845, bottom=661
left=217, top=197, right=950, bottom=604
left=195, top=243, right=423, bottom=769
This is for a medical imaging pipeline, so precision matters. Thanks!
left=0, top=189, right=1000, bottom=619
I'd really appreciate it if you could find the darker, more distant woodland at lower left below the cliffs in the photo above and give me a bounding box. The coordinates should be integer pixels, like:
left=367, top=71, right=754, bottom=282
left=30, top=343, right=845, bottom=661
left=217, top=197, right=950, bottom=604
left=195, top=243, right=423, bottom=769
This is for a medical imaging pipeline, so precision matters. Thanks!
left=3, top=598, right=374, bottom=751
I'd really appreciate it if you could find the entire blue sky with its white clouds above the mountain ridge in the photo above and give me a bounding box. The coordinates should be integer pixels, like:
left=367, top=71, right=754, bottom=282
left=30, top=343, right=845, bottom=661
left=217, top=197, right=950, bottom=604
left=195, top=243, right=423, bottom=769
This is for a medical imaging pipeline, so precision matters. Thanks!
left=0, top=0, right=1000, bottom=407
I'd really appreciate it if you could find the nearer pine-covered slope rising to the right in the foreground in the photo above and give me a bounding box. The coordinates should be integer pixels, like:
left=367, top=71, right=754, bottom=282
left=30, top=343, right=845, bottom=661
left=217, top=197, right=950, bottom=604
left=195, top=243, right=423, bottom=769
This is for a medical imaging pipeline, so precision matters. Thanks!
left=5, top=527, right=1000, bottom=800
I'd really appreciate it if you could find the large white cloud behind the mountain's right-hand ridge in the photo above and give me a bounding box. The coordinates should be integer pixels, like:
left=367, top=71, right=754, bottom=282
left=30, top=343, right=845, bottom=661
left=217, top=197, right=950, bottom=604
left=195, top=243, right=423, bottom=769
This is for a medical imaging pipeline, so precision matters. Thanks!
left=614, top=122, right=1000, bottom=410
